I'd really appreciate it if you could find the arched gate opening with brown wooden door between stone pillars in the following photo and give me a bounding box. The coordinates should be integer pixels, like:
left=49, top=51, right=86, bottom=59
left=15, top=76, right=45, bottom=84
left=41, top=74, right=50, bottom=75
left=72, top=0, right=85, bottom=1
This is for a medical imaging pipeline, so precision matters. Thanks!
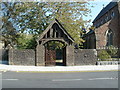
left=44, top=41, right=66, bottom=66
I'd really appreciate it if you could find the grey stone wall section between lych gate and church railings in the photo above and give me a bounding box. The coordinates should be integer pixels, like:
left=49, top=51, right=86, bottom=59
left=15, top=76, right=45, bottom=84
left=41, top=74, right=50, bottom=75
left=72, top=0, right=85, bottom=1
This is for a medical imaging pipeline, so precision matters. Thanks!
left=74, top=49, right=97, bottom=66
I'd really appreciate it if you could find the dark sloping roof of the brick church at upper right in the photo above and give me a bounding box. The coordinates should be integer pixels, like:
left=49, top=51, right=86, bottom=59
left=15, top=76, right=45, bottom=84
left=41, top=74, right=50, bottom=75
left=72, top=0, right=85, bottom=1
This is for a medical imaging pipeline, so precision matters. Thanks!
left=93, top=2, right=117, bottom=23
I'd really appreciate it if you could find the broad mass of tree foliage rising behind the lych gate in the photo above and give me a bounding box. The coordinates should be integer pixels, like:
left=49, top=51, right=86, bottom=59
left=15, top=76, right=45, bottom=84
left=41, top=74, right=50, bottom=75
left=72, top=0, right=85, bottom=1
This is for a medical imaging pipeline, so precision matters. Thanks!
left=2, top=2, right=90, bottom=48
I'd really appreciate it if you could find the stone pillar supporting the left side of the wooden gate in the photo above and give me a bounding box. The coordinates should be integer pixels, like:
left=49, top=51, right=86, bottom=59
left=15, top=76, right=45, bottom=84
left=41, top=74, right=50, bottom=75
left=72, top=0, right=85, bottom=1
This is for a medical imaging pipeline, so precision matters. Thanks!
left=36, top=45, right=45, bottom=66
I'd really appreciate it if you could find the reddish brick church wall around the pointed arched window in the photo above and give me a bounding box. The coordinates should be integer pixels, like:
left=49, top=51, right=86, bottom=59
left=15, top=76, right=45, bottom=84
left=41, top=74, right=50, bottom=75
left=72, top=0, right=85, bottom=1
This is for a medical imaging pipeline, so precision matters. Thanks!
left=95, top=6, right=120, bottom=48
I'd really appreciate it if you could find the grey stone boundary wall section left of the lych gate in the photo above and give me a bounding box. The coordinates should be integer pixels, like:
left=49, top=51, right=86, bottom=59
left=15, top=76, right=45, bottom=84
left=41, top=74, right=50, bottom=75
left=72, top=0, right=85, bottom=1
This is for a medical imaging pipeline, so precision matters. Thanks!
left=9, top=49, right=35, bottom=66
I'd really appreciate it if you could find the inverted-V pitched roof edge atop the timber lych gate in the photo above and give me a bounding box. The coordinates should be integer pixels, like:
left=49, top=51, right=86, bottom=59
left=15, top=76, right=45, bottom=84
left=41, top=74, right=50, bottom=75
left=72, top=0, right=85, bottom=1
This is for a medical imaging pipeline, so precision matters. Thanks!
left=37, top=19, right=74, bottom=42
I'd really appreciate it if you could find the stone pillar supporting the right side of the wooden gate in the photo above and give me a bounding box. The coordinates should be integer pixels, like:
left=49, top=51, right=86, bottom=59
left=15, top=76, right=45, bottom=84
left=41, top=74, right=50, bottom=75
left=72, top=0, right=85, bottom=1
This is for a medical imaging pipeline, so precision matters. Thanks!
left=66, top=46, right=74, bottom=66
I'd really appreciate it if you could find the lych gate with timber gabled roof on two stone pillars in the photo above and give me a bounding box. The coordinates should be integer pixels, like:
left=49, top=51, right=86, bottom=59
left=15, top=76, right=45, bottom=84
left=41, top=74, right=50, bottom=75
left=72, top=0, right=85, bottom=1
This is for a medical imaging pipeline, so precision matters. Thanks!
left=36, top=19, right=74, bottom=66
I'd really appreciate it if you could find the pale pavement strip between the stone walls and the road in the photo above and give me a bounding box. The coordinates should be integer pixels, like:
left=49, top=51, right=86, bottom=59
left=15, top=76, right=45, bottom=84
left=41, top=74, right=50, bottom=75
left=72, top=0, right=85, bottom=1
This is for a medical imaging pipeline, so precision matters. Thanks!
left=0, top=64, right=120, bottom=72
